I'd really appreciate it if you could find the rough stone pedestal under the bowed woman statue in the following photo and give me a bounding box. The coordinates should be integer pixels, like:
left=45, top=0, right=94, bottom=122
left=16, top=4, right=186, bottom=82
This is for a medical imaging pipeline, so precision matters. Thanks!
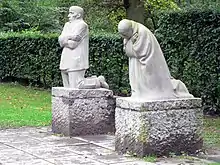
left=115, top=98, right=203, bottom=157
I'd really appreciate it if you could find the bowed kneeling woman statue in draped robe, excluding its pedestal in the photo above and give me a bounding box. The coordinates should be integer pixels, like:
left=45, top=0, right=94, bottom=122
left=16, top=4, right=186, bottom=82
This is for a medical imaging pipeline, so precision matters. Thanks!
left=118, top=19, right=193, bottom=101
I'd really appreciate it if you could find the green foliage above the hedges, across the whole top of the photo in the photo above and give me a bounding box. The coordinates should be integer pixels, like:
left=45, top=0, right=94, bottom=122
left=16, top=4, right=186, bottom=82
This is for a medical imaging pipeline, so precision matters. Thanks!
left=0, top=0, right=220, bottom=33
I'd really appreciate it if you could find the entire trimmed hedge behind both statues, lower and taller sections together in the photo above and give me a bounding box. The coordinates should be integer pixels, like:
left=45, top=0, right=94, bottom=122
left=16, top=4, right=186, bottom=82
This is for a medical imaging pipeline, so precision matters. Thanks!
left=0, top=10, right=220, bottom=112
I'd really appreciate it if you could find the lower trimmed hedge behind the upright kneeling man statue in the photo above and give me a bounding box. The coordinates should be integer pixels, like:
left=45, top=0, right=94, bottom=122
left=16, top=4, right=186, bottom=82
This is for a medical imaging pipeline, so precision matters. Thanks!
left=0, top=33, right=129, bottom=94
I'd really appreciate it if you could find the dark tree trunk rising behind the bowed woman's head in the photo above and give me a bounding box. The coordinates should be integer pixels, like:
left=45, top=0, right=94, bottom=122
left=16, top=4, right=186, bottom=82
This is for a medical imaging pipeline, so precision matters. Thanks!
left=124, top=0, right=145, bottom=24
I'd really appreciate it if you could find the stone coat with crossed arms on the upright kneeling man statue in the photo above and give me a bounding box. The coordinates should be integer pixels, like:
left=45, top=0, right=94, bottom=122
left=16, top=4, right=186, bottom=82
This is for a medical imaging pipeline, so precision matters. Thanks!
left=59, top=20, right=89, bottom=72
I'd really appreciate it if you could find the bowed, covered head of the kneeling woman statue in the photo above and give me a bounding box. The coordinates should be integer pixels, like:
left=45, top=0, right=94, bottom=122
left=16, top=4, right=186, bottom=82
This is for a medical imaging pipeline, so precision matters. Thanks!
left=118, top=19, right=133, bottom=39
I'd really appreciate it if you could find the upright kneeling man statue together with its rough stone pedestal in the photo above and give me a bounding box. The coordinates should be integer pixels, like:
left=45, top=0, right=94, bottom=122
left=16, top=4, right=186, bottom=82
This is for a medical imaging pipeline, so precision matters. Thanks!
left=52, top=6, right=115, bottom=136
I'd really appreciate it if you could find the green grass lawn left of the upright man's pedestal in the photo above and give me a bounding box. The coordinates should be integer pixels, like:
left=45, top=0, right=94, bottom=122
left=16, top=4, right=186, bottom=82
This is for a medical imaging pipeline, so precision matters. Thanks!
left=0, top=83, right=51, bottom=128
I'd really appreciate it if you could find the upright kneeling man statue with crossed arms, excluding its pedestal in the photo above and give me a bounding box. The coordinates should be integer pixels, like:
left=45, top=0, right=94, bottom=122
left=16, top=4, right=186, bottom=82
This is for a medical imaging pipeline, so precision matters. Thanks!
left=58, top=6, right=109, bottom=89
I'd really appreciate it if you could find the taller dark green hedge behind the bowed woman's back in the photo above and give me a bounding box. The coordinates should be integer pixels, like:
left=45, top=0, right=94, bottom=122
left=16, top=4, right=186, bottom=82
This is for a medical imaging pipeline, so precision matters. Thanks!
left=156, top=10, right=220, bottom=112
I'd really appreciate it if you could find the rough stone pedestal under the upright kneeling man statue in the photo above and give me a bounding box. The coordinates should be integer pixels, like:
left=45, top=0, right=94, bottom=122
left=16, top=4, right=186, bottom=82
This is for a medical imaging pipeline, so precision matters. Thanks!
left=52, top=87, right=115, bottom=136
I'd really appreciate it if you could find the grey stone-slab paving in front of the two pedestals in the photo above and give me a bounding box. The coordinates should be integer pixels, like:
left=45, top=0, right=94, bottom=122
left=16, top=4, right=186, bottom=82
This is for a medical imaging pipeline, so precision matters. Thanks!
left=0, top=127, right=218, bottom=165
